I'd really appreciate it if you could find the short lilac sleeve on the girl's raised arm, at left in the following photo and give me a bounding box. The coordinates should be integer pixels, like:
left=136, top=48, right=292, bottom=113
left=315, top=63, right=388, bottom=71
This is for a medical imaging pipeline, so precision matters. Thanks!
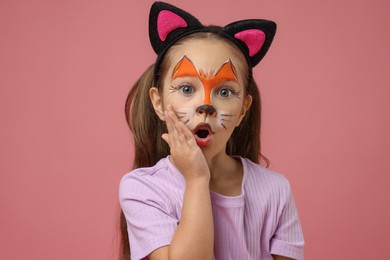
left=119, top=173, right=178, bottom=260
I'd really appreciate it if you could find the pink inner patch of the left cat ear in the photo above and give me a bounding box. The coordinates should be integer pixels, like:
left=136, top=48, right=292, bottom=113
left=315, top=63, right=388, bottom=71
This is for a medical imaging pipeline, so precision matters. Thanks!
left=157, top=10, right=187, bottom=41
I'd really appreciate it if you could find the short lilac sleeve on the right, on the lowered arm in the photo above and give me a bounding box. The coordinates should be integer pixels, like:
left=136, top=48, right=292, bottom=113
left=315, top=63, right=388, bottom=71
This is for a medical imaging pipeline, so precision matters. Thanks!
left=270, top=180, right=305, bottom=260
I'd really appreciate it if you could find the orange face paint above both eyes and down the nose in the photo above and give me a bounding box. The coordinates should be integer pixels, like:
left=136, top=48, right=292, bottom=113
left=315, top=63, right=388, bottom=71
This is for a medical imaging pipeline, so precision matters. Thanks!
left=172, top=56, right=237, bottom=105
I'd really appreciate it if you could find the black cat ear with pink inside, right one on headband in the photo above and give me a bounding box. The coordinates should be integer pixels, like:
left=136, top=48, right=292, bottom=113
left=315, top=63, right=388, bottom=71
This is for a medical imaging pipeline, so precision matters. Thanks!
left=222, top=19, right=276, bottom=68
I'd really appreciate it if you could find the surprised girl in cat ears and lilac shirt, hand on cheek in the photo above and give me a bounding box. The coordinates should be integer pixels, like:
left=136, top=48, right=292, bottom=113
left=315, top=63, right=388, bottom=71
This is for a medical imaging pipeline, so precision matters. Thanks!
left=119, top=2, right=304, bottom=260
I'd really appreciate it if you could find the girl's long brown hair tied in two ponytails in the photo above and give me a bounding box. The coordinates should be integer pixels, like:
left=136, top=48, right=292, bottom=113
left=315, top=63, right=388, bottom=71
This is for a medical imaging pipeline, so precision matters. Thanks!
left=119, top=32, right=269, bottom=260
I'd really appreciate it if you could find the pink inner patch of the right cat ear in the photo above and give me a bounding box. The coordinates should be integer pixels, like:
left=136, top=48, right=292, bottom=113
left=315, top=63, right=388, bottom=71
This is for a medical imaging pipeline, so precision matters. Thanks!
left=234, top=29, right=266, bottom=57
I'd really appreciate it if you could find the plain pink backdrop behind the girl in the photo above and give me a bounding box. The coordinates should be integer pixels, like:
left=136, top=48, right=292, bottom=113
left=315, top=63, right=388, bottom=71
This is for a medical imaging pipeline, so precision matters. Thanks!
left=0, top=0, right=390, bottom=260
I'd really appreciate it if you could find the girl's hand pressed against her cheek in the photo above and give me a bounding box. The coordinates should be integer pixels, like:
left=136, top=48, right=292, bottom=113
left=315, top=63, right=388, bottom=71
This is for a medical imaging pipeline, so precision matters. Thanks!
left=162, top=105, right=210, bottom=183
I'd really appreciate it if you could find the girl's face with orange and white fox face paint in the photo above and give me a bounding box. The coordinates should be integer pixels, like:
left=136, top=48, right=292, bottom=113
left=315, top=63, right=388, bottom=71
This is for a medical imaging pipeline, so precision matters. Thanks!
left=150, top=39, right=252, bottom=156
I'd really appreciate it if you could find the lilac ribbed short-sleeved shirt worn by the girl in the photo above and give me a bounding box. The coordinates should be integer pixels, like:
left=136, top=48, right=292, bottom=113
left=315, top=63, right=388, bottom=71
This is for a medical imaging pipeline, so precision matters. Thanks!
left=119, top=157, right=304, bottom=260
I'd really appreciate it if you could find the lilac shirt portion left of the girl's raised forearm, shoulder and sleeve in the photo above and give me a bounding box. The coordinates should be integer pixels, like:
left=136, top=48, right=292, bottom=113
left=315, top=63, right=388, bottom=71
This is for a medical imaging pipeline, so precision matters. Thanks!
left=119, top=158, right=184, bottom=259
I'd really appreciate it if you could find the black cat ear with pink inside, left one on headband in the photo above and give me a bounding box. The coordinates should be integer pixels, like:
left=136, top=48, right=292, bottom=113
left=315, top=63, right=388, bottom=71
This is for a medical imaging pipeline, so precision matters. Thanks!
left=149, top=2, right=204, bottom=55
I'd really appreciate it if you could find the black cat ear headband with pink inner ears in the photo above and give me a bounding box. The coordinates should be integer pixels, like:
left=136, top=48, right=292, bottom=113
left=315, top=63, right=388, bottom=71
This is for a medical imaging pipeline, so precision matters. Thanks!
left=149, top=2, right=276, bottom=84
